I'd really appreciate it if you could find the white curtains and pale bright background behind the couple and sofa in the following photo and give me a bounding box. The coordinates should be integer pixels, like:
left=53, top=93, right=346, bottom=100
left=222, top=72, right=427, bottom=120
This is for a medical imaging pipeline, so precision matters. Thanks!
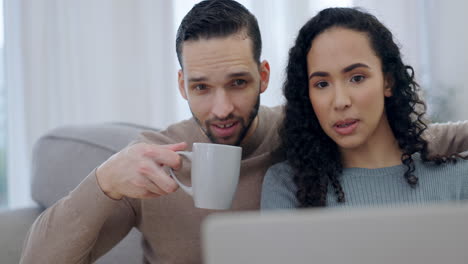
left=5, top=0, right=468, bottom=207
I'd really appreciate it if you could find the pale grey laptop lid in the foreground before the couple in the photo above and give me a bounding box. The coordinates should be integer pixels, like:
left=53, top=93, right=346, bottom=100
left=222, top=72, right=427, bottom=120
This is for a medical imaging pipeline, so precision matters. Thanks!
left=202, top=204, right=468, bottom=264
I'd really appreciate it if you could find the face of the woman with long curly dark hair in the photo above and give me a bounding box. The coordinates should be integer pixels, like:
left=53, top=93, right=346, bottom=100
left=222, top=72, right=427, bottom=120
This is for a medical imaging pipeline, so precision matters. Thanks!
left=307, top=27, right=391, bottom=149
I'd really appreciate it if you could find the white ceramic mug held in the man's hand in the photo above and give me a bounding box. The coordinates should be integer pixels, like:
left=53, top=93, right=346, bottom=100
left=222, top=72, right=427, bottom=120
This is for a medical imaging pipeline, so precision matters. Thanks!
left=170, top=143, right=242, bottom=210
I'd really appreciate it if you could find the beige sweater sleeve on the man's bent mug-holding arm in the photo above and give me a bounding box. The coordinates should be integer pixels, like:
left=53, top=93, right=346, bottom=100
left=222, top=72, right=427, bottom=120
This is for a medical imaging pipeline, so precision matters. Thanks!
left=20, top=170, right=136, bottom=264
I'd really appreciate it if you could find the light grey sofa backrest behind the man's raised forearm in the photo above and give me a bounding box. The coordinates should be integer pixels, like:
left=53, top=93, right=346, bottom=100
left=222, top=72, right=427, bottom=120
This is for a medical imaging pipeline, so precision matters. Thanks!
left=31, top=123, right=155, bottom=208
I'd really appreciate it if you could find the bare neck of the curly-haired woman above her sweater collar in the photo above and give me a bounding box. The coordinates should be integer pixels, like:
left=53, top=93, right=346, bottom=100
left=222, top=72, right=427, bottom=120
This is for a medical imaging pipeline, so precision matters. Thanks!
left=340, top=116, right=403, bottom=169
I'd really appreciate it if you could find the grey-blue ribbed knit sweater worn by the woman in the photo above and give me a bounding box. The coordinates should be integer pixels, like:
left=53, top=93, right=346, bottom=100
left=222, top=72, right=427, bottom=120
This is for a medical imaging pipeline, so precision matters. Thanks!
left=261, top=155, right=468, bottom=209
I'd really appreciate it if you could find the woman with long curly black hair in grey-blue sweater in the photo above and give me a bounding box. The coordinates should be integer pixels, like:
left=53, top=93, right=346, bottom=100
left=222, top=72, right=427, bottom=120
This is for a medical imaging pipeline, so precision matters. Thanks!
left=261, top=8, right=468, bottom=209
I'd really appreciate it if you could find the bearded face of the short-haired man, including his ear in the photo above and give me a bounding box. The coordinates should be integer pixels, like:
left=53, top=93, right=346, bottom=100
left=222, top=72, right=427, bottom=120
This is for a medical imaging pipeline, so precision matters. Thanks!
left=178, top=32, right=270, bottom=145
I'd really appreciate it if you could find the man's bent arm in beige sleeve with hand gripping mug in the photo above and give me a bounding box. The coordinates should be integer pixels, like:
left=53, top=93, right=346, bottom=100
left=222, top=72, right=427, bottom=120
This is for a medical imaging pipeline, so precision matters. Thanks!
left=21, top=141, right=187, bottom=264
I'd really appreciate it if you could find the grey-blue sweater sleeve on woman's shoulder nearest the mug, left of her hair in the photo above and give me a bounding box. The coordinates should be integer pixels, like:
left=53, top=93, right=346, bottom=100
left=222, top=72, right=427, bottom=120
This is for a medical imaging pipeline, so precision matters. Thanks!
left=261, top=162, right=298, bottom=210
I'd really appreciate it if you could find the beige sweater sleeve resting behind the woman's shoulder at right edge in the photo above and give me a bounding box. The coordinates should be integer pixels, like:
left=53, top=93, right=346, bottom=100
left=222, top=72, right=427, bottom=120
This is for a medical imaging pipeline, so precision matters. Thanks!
left=424, top=121, right=468, bottom=155
